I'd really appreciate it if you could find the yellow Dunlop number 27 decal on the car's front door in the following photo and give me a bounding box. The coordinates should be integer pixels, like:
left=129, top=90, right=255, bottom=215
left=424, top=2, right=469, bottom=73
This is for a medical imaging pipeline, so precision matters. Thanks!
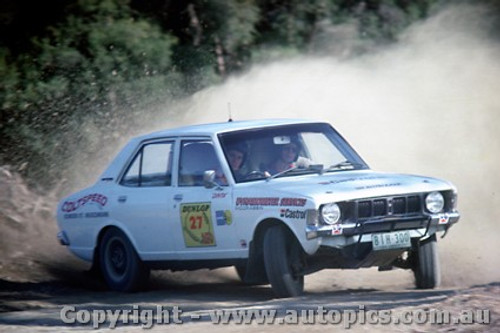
left=180, top=202, right=216, bottom=247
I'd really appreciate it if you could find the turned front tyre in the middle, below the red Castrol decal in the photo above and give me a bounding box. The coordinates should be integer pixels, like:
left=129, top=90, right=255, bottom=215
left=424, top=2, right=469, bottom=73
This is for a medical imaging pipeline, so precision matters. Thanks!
left=264, top=225, right=304, bottom=297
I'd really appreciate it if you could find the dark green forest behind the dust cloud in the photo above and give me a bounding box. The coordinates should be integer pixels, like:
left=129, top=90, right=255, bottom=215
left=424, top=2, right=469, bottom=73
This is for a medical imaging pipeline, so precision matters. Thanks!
left=0, top=0, right=500, bottom=188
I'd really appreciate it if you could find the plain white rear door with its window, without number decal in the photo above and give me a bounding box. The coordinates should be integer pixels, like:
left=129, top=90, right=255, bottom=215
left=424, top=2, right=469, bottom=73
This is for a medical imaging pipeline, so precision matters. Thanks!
left=114, top=139, right=179, bottom=260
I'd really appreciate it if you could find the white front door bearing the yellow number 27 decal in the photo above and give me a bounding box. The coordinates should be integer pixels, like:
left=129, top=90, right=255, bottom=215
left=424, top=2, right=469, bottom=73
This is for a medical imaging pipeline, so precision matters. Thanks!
left=174, top=138, right=239, bottom=259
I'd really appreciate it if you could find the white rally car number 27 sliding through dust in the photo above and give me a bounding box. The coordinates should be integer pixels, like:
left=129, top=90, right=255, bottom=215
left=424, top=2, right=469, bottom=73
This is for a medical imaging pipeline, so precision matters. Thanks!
left=57, top=119, right=460, bottom=297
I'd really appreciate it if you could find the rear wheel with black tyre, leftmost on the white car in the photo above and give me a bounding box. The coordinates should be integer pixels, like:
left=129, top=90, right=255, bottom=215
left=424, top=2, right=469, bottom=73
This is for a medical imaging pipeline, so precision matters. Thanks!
left=99, top=228, right=150, bottom=291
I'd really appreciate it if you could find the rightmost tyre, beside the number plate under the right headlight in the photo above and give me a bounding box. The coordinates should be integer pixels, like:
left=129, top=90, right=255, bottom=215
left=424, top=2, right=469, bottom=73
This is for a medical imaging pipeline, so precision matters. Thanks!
left=413, top=234, right=441, bottom=289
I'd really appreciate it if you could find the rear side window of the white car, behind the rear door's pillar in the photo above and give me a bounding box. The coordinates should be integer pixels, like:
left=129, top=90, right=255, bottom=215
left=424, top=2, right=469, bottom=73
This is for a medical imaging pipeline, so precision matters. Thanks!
left=120, top=142, right=174, bottom=187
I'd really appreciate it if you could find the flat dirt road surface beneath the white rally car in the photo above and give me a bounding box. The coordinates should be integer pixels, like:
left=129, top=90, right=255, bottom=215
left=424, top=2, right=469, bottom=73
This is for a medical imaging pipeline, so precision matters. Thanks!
left=0, top=250, right=500, bottom=332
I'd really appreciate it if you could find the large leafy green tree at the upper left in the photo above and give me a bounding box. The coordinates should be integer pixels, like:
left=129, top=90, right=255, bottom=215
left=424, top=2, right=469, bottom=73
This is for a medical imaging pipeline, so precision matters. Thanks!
left=0, top=0, right=180, bottom=187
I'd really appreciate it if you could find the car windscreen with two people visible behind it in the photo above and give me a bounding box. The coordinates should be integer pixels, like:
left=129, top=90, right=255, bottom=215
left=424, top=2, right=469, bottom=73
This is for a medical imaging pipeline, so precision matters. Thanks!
left=219, top=123, right=368, bottom=182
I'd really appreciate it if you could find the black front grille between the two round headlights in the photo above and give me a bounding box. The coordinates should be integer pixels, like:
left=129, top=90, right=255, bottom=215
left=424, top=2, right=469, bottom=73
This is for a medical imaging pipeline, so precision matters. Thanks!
left=350, top=195, right=422, bottom=220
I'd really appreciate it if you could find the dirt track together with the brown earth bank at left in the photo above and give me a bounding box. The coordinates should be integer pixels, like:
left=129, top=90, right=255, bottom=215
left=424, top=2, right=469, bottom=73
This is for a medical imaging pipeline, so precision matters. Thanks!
left=0, top=165, right=500, bottom=332
